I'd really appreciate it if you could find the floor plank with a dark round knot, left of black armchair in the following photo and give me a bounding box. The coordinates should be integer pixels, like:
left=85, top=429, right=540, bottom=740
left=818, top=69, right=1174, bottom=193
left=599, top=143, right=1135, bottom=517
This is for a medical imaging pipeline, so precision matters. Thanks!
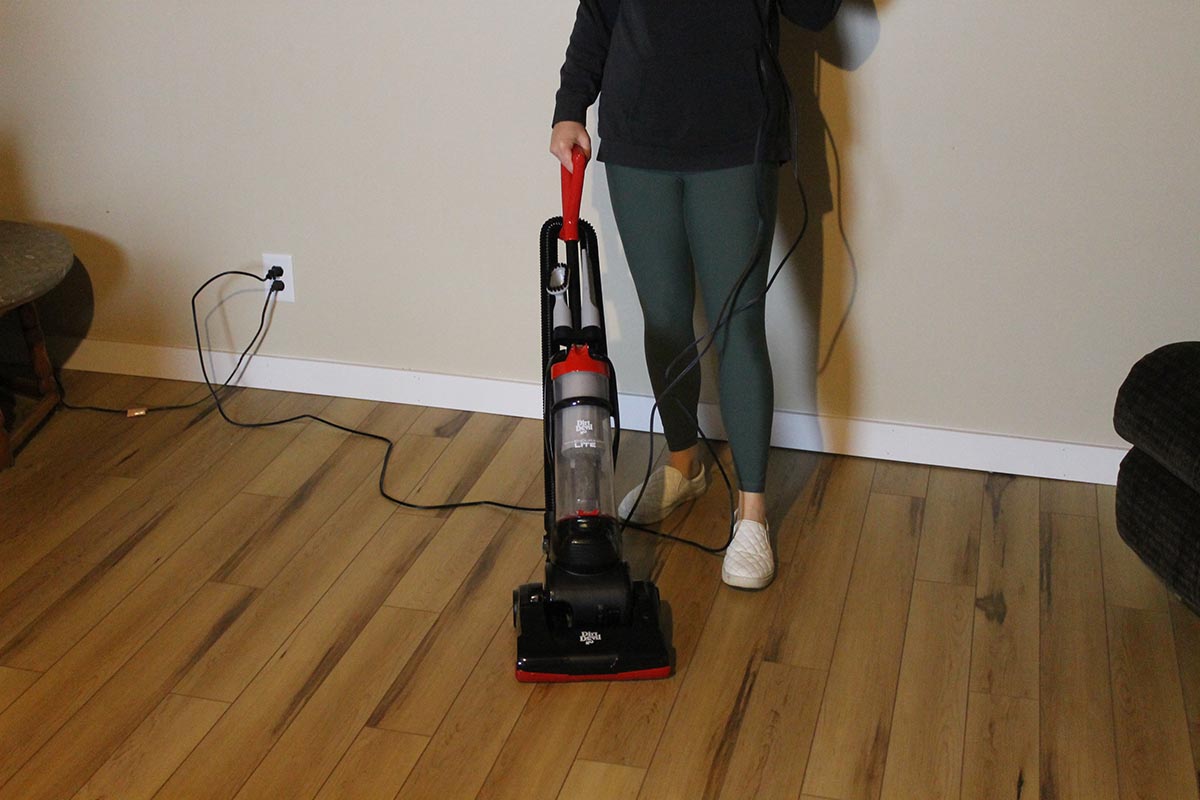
left=971, top=475, right=1039, bottom=699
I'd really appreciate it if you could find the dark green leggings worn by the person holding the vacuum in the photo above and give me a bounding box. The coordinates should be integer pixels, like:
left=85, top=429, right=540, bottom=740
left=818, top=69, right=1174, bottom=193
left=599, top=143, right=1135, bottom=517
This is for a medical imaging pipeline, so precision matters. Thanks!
left=605, top=164, right=779, bottom=492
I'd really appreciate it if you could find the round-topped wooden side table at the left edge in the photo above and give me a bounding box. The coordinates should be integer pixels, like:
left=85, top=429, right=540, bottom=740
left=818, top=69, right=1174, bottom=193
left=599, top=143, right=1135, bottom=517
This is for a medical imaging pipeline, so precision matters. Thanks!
left=0, top=221, right=74, bottom=469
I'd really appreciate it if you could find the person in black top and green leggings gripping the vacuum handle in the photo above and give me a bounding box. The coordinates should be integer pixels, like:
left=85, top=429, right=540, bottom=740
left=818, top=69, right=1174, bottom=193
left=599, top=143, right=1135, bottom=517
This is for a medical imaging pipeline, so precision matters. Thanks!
left=550, top=0, right=840, bottom=589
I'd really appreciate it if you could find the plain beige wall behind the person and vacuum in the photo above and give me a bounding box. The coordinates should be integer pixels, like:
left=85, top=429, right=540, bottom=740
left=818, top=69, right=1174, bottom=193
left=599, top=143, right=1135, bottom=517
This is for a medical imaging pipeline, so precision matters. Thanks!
left=0, top=0, right=1200, bottom=445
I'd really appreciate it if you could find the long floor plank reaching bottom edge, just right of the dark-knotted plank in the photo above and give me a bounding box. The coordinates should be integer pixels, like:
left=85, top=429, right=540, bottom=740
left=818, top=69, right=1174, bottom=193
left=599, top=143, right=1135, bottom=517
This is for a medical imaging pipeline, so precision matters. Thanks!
left=1039, top=513, right=1120, bottom=800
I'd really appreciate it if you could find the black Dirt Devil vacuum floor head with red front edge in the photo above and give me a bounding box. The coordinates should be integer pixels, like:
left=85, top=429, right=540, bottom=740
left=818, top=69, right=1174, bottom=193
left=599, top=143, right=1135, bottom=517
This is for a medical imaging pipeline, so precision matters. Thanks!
left=514, top=581, right=671, bottom=682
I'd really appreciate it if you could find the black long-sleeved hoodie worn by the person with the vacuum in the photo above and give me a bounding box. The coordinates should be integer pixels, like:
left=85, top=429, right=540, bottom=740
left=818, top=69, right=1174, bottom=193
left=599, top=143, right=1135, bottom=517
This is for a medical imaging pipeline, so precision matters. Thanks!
left=554, top=0, right=841, bottom=170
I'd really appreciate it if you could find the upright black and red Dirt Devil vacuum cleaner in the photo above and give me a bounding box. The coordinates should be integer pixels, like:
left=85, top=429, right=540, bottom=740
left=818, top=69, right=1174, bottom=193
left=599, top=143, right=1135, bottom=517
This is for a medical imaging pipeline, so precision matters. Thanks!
left=512, top=148, right=672, bottom=682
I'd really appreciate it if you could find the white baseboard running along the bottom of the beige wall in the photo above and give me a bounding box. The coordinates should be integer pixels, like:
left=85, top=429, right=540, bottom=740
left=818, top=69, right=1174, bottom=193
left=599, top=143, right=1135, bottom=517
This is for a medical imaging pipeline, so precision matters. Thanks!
left=52, top=339, right=1128, bottom=485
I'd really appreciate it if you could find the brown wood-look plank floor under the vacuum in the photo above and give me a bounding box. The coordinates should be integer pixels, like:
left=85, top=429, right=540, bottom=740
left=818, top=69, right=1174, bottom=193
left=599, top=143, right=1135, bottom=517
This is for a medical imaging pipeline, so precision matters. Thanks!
left=0, top=373, right=1200, bottom=800
